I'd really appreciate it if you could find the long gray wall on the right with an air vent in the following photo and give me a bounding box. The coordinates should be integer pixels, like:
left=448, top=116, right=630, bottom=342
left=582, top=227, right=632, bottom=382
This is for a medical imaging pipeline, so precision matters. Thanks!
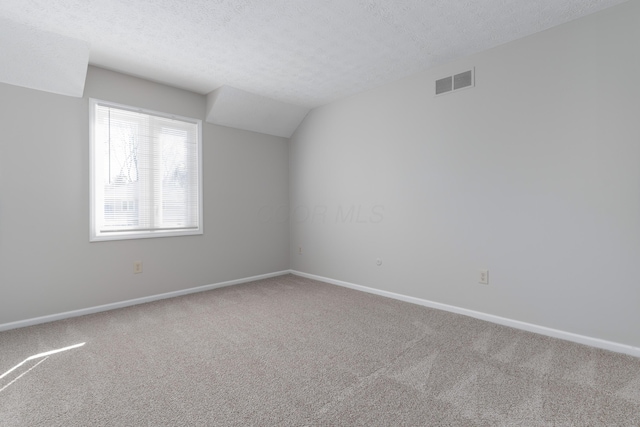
left=290, top=1, right=640, bottom=346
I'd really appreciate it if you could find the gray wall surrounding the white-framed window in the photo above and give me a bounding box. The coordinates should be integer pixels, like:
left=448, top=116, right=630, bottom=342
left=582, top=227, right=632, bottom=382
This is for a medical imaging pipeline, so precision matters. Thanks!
left=0, top=67, right=289, bottom=324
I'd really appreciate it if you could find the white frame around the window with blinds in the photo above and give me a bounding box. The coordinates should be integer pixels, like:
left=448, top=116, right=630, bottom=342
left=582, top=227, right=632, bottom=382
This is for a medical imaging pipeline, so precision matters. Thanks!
left=89, top=98, right=204, bottom=242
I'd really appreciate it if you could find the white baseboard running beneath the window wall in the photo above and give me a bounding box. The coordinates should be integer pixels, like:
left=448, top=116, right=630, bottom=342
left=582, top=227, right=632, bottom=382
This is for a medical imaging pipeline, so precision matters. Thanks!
left=0, top=270, right=291, bottom=332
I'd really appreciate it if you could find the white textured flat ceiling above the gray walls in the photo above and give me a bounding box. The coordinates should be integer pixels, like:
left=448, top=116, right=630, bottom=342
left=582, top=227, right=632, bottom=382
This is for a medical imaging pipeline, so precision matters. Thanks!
left=0, top=0, right=624, bottom=107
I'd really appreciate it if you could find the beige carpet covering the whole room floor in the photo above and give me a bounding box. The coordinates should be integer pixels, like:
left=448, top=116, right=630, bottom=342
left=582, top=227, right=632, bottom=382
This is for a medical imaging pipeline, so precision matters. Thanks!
left=0, top=275, right=640, bottom=426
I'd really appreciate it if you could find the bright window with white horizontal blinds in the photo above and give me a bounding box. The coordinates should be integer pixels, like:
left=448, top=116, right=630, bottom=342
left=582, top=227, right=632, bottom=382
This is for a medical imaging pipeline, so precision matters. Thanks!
left=89, top=99, right=202, bottom=241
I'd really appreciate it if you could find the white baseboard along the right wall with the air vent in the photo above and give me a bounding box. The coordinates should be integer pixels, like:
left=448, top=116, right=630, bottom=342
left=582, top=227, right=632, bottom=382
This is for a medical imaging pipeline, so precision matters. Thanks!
left=291, top=270, right=640, bottom=357
